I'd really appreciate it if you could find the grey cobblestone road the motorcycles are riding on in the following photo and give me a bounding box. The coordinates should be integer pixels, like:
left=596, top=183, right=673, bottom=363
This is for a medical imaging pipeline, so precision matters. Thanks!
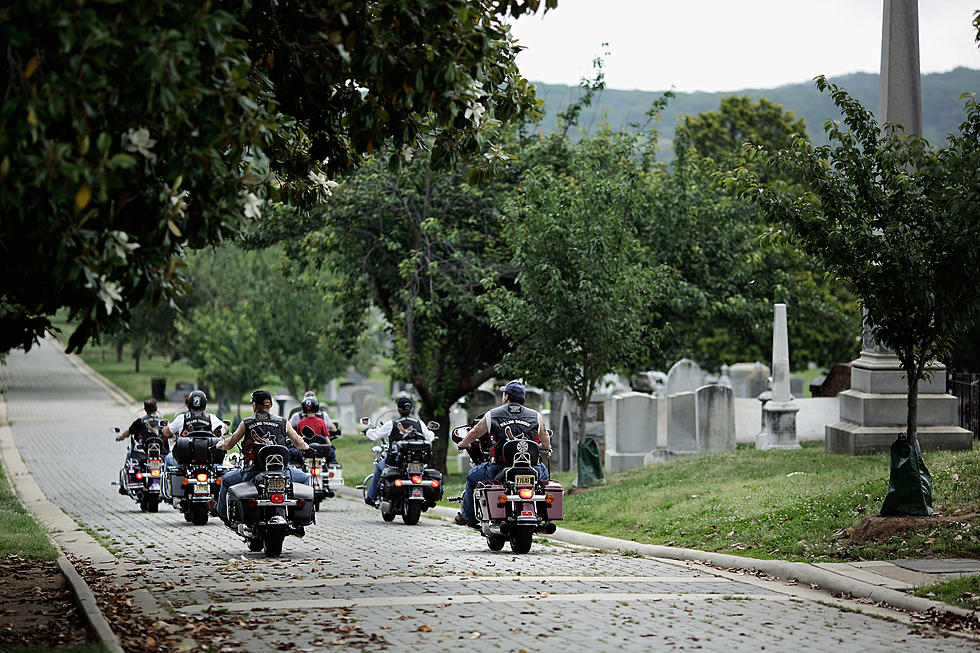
left=0, top=342, right=976, bottom=652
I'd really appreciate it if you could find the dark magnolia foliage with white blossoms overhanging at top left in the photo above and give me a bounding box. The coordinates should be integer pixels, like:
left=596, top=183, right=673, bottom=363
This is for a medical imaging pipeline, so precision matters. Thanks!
left=0, top=0, right=556, bottom=352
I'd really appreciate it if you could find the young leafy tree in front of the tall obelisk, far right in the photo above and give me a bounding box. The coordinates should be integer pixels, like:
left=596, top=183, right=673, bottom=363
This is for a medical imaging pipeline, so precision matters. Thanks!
left=726, top=77, right=980, bottom=444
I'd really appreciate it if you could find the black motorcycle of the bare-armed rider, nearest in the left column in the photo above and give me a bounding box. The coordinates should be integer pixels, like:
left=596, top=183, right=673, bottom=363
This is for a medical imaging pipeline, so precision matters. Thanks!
left=227, top=429, right=326, bottom=558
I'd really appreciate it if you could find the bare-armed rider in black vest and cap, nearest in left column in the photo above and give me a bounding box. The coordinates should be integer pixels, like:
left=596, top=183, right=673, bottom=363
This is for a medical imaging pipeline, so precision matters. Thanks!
left=215, top=390, right=310, bottom=523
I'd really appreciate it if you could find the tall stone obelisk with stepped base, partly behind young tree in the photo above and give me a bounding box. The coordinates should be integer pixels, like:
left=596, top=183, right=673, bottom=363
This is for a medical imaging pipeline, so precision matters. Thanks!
left=825, top=0, right=973, bottom=455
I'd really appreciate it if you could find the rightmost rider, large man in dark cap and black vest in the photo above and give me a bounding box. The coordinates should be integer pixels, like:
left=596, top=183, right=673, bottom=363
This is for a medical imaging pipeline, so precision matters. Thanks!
left=455, top=381, right=551, bottom=526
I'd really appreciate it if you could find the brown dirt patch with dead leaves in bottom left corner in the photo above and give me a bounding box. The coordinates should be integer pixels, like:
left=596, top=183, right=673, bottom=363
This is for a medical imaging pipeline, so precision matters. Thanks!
left=0, top=555, right=94, bottom=650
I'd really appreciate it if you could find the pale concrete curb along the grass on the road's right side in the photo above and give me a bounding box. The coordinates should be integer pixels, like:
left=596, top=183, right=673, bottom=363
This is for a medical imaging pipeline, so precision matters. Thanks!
left=339, top=486, right=980, bottom=620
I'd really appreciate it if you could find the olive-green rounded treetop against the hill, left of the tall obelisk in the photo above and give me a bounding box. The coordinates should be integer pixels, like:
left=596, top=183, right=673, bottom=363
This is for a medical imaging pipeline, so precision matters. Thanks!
left=677, top=95, right=810, bottom=181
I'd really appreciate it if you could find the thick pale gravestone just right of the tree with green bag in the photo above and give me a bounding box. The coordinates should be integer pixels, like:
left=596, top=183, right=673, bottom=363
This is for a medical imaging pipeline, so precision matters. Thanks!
left=605, top=392, right=657, bottom=472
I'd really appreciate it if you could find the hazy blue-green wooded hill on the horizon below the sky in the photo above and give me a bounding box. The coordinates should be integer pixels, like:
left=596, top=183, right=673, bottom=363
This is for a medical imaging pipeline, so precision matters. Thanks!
left=534, top=68, right=980, bottom=157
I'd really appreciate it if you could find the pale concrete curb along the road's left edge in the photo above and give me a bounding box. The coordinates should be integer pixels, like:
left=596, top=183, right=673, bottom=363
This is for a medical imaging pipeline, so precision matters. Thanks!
left=0, top=395, right=124, bottom=653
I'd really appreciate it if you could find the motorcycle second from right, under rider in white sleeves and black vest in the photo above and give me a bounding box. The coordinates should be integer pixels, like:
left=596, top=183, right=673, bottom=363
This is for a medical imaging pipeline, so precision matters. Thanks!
left=357, top=417, right=443, bottom=526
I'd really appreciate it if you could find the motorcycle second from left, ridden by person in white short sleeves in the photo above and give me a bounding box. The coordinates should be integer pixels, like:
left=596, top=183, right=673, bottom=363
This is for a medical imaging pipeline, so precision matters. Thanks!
left=162, top=431, right=225, bottom=526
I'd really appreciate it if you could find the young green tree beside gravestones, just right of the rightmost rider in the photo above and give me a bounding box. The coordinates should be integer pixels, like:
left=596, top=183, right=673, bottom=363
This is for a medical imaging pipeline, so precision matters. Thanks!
left=481, top=130, right=663, bottom=441
